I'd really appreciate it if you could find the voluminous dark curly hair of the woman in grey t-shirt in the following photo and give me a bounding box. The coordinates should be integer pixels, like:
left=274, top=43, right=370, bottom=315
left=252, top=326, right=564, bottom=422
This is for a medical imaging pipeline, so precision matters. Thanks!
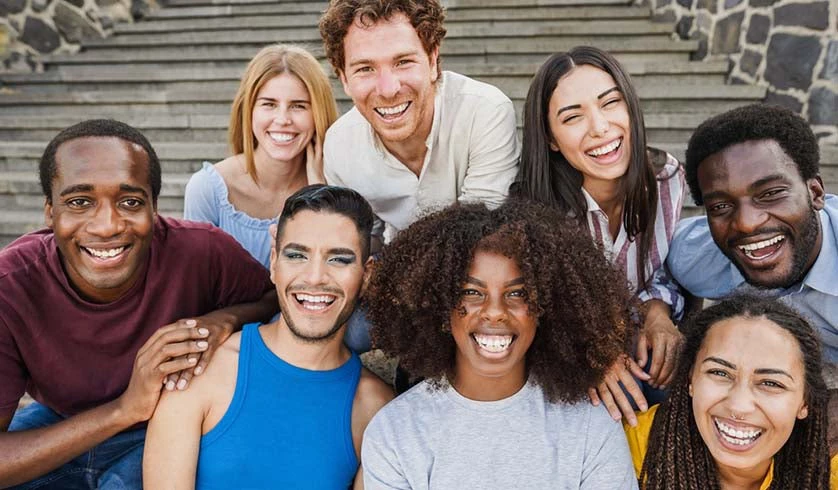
left=366, top=199, right=632, bottom=402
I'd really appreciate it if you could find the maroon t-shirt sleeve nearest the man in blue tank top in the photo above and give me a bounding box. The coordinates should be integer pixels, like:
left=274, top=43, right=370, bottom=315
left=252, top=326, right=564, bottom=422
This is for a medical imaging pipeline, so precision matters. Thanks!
left=209, top=229, right=273, bottom=309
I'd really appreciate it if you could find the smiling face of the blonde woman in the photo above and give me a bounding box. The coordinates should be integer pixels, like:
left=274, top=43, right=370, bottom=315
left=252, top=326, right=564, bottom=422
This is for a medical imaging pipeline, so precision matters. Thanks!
left=251, top=73, right=314, bottom=166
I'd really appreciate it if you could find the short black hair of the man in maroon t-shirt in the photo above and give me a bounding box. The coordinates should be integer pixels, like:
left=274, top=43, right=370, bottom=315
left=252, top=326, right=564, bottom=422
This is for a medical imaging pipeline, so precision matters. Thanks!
left=38, top=119, right=162, bottom=203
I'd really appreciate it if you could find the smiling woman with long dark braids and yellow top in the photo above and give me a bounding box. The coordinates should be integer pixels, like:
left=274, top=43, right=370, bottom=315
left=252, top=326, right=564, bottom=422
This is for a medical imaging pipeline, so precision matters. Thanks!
left=625, top=296, right=838, bottom=490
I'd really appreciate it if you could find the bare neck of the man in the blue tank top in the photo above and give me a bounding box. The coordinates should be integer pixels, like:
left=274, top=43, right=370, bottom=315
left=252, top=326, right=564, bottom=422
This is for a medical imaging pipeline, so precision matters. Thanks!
left=262, top=316, right=351, bottom=371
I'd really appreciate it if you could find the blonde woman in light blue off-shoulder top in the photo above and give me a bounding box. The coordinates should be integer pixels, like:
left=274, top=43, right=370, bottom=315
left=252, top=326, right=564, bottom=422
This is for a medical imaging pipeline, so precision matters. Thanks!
left=183, top=44, right=338, bottom=267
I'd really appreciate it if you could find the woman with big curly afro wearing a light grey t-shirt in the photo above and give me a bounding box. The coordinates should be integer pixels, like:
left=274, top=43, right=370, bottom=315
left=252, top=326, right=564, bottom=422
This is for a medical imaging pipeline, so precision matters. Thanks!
left=361, top=201, right=637, bottom=490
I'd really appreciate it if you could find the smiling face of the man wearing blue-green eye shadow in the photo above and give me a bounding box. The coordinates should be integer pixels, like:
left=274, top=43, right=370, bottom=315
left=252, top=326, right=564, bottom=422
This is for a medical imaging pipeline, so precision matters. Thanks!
left=271, top=210, right=369, bottom=342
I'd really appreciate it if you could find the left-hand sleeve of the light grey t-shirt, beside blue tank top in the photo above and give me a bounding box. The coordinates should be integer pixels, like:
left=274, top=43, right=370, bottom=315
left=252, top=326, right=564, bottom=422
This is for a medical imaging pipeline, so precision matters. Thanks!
left=361, top=407, right=410, bottom=490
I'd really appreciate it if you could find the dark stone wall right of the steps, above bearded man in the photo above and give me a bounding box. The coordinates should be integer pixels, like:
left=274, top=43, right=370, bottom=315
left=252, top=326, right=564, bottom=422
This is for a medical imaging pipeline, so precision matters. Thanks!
left=641, top=0, right=838, bottom=143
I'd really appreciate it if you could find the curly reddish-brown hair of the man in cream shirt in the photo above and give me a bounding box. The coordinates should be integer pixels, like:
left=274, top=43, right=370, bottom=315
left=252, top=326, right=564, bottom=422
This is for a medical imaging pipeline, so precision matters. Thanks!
left=320, top=0, right=445, bottom=79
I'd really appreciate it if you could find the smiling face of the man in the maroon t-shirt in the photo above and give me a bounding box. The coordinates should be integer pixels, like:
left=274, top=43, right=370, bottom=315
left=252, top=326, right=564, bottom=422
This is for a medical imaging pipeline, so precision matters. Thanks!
left=44, top=137, right=155, bottom=303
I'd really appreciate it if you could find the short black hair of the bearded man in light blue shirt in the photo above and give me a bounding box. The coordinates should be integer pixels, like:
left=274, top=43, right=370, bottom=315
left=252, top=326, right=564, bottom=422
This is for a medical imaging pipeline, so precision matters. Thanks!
left=686, top=104, right=820, bottom=205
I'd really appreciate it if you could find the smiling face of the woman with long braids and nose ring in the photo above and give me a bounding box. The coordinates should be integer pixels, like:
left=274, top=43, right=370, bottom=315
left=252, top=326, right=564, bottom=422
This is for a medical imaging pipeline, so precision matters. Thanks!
left=690, top=317, right=808, bottom=474
